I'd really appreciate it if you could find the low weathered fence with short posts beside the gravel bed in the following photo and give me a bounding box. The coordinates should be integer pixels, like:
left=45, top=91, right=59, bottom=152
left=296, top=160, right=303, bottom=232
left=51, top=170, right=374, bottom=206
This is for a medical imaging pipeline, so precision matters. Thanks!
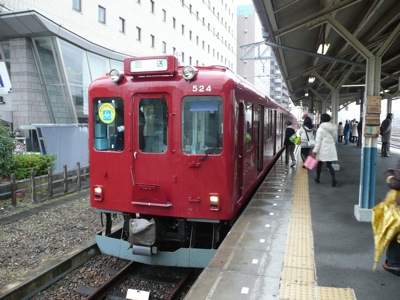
left=0, top=163, right=89, bottom=206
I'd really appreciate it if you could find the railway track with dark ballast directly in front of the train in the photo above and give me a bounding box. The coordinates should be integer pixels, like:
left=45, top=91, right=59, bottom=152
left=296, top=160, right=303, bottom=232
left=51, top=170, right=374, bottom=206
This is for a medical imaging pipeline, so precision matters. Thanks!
left=1, top=237, right=201, bottom=300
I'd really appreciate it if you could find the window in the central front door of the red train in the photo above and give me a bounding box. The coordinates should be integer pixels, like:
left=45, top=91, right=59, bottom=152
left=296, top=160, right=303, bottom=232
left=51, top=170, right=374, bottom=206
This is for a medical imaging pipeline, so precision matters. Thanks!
left=138, top=98, right=168, bottom=153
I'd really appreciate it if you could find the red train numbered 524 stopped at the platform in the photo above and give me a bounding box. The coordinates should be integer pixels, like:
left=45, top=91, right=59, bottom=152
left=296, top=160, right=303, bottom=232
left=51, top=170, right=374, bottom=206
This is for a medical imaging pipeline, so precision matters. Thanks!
left=89, top=56, right=296, bottom=267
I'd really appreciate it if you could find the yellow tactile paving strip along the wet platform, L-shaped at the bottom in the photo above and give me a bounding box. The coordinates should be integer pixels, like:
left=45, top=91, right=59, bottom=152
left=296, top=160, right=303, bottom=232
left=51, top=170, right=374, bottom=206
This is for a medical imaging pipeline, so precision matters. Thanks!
left=279, top=168, right=356, bottom=300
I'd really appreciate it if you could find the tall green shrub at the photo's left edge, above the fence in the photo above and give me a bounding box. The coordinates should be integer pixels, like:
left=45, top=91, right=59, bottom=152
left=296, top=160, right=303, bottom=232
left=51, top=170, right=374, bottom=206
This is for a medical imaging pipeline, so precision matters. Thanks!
left=0, top=124, right=15, bottom=182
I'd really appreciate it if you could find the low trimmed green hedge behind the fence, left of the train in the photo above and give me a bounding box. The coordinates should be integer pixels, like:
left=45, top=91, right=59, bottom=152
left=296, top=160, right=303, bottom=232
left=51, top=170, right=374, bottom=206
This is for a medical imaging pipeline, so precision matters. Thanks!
left=13, top=154, right=57, bottom=180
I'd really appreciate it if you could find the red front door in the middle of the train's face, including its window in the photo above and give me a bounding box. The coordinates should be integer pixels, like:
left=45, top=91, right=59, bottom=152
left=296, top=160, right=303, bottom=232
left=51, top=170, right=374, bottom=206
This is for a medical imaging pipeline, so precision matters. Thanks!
left=132, top=94, right=171, bottom=207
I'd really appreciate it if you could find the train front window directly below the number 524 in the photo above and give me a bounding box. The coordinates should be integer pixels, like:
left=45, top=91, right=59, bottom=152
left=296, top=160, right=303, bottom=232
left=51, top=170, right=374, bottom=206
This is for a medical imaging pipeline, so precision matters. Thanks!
left=182, top=96, right=223, bottom=155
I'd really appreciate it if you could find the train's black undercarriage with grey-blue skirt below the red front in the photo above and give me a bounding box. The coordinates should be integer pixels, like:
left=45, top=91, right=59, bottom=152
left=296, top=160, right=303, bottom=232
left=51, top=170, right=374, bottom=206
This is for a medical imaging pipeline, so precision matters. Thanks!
left=96, top=212, right=231, bottom=268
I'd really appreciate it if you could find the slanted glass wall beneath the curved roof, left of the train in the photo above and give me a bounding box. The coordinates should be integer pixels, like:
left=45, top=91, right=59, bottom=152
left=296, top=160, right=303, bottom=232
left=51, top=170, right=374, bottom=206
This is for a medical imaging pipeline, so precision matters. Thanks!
left=33, top=37, right=123, bottom=124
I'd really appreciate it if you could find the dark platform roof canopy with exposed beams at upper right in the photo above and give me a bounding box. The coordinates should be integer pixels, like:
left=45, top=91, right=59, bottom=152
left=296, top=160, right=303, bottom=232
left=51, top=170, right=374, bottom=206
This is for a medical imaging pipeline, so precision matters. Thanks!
left=253, top=0, right=400, bottom=108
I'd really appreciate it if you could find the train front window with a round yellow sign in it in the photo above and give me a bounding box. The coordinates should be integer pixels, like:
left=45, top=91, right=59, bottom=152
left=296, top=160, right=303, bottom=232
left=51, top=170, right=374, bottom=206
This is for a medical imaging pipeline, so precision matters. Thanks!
left=93, top=98, right=125, bottom=151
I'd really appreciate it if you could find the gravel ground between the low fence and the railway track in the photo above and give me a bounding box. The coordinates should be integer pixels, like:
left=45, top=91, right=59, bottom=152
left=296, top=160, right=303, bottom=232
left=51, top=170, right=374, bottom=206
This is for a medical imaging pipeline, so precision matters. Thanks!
left=0, top=190, right=101, bottom=288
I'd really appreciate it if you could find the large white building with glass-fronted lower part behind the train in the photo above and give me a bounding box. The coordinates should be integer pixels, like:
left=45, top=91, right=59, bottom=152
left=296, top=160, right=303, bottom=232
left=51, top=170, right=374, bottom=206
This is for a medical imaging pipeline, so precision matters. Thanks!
left=0, top=0, right=237, bottom=130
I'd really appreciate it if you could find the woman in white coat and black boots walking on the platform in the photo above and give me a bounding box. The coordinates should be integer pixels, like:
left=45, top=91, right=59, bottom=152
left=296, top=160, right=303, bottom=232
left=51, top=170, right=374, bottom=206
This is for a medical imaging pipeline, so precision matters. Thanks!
left=312, top=114, right=338, bottom=187
